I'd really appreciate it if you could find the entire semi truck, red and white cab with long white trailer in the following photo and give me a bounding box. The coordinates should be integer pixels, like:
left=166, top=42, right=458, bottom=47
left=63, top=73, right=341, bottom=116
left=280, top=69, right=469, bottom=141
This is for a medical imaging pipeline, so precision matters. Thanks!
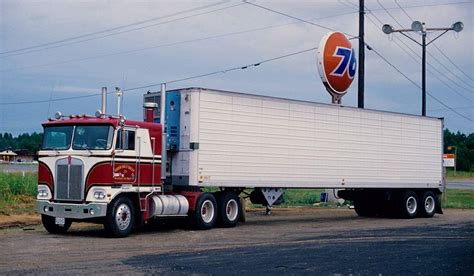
left=37, top=85, right=444, bottom=237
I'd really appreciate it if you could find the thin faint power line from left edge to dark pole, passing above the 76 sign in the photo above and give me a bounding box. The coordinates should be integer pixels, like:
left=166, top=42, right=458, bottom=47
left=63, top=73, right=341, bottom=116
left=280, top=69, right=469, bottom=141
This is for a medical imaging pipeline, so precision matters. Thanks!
left=0, top=12, right=355, bottom=72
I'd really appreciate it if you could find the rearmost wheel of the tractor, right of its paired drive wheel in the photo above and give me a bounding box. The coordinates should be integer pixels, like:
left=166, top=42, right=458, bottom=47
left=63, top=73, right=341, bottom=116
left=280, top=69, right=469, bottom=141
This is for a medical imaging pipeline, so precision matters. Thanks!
left=217, top=191, right=242, bottom=228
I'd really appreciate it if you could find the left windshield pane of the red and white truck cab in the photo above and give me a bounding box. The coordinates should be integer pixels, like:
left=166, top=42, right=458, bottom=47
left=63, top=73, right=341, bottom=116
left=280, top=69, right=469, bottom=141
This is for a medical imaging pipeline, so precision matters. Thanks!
left=42, top=126, right=73, bottom=150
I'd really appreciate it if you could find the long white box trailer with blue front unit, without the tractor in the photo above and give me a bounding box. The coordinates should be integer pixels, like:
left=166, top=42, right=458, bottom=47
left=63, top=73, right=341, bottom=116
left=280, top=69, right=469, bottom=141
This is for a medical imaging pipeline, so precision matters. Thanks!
left=144, top=88, right=444, bottom=217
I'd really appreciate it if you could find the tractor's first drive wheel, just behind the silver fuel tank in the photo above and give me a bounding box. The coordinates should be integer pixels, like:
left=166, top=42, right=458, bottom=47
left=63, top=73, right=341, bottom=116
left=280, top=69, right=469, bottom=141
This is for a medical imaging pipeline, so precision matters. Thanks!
left=191, top=193, right=217, bottom=230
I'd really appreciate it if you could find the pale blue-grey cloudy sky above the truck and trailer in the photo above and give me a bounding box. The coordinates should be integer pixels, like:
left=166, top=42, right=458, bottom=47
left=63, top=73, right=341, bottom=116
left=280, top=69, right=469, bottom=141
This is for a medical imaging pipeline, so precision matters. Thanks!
left=0, top=0, right=474, bottom=135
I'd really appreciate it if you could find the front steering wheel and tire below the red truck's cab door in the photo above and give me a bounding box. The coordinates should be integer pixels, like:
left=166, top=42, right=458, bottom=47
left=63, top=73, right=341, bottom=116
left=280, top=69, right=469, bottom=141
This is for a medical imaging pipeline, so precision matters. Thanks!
left=104, top=196, right=136, bottom=238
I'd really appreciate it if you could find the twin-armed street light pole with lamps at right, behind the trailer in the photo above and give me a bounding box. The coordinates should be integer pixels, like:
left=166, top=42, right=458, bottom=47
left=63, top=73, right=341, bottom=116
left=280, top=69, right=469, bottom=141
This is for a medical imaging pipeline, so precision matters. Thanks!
left=382, top=21, right=464, bottom=116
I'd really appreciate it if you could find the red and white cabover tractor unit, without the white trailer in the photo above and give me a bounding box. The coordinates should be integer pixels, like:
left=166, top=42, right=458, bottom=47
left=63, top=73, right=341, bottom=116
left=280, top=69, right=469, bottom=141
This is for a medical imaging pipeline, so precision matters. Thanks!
left=37, top=109, right=240, bottom=237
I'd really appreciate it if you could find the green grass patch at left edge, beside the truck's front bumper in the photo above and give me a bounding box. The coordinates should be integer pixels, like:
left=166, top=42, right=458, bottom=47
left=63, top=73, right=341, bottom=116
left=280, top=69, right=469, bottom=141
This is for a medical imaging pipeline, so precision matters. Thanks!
left=0, top=172, right=38, bottom=215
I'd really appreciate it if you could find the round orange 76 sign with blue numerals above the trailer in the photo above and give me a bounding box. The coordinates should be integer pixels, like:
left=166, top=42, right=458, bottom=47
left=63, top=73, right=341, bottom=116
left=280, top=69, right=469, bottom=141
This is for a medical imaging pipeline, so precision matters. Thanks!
left=318, top=32, right=357, bottom=96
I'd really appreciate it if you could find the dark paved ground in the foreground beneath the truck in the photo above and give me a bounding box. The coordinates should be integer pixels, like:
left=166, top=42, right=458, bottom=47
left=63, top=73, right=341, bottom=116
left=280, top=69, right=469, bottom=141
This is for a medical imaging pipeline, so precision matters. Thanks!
left=0, top=209, right=474, bottom=275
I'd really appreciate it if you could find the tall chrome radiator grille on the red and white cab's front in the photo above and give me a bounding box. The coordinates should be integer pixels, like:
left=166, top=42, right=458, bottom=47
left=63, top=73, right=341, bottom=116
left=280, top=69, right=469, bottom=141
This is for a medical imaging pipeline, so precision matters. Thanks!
left=55, top=158, right=84, bottom=201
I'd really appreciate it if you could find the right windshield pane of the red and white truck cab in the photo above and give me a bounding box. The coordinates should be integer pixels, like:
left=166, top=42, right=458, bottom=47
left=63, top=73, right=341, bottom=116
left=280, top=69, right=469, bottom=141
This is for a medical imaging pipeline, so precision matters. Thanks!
left=72, top=125, right=114, bottom=150
